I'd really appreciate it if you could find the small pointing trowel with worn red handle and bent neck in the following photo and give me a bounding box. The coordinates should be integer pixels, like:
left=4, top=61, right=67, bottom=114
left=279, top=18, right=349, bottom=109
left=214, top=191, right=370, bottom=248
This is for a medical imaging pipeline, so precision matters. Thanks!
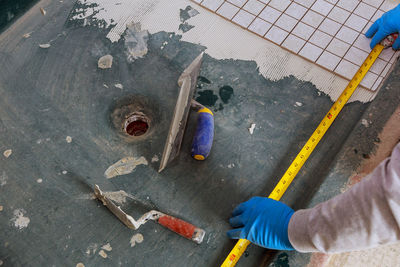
left=94, top=185, right=205, bottom=244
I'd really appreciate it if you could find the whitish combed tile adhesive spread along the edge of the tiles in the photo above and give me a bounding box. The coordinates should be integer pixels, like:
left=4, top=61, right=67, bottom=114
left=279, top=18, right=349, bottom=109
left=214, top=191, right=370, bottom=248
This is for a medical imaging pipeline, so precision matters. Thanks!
left=71, top=0, right=390, bottom=103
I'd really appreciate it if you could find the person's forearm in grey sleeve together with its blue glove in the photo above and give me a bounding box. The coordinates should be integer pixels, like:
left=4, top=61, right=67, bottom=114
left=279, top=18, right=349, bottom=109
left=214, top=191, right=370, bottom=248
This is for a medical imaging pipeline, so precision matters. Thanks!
left=227, top=143, right=400, bottom=253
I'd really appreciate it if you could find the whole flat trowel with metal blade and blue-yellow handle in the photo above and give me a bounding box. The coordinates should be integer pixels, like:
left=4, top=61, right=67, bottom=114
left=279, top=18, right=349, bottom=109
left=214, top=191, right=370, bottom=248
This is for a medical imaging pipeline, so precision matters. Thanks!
left=158, top=52, right=214, bottom=172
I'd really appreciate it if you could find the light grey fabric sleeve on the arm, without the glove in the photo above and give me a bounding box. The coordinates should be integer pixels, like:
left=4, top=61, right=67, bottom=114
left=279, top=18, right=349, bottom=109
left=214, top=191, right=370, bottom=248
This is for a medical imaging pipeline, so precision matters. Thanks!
left=288, top=143, right=400, bottom=253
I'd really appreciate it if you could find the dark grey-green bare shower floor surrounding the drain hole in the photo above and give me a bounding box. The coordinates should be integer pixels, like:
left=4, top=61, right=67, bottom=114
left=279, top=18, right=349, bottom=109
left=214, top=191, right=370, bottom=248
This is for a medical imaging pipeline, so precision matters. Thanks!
left=0, top=2, right=398, bottom=266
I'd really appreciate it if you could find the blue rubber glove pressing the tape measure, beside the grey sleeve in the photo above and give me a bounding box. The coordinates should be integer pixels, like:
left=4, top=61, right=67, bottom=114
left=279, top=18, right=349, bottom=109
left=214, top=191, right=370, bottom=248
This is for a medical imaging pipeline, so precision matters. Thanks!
left=227, top=197, right=294, bottom=250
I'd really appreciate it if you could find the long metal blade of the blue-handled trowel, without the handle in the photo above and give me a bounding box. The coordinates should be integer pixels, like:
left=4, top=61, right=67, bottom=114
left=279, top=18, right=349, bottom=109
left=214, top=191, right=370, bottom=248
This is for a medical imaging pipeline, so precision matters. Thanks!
left=158, top=52, right=204, bottom=172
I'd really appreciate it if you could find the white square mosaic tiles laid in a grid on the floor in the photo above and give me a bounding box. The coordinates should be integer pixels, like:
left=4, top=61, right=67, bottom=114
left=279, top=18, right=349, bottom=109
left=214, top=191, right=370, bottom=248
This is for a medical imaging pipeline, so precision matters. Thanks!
left=193, top=0, right=399, bottom=90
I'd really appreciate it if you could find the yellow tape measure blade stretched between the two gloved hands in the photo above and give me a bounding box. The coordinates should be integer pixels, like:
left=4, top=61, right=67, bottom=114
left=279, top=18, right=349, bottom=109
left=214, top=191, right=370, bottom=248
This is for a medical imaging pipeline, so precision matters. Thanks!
left=221, top=44, right=384, bottom=267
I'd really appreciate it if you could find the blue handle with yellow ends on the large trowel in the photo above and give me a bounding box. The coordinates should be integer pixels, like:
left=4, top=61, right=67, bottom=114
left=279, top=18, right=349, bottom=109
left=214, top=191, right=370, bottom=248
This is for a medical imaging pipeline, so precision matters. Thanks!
left=192, top=108, right=214, bottom=160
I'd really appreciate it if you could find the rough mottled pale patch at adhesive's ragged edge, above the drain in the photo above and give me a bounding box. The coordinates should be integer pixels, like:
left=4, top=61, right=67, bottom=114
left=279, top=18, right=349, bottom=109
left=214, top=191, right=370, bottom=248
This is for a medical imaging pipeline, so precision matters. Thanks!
left=124, top=23, right=149, bottom=62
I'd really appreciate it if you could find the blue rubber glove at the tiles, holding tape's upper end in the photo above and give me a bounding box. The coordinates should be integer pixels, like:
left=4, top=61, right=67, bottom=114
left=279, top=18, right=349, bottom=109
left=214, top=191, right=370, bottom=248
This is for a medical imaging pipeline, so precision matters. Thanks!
left=365, top=5, right=400, bottom=50
